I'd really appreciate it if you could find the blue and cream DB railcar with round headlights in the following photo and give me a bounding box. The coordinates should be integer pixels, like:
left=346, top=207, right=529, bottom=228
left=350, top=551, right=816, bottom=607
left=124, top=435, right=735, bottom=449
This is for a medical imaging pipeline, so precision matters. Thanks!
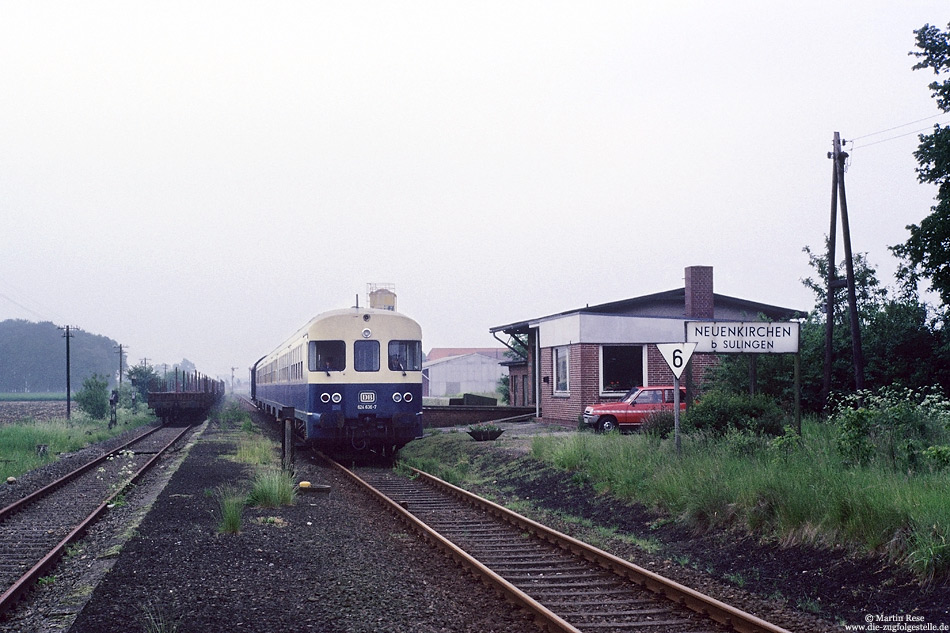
left=251, top=308, right=422, bottom=453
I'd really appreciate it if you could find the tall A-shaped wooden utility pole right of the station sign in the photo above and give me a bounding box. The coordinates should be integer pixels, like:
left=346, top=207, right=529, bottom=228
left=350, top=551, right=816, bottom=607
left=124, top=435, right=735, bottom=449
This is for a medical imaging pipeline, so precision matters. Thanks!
left=824, top=132, right=864, bottom=398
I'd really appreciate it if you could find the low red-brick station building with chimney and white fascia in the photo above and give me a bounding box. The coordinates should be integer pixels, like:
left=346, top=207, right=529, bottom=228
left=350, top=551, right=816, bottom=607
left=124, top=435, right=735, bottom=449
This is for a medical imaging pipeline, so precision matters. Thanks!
left=489, top=266, right=804, bottom=425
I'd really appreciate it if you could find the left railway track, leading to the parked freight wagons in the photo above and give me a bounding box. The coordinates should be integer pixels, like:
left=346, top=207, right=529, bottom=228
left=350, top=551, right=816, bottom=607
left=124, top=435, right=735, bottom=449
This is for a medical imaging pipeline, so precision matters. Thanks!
left=0, top=426, right=192, bottom=614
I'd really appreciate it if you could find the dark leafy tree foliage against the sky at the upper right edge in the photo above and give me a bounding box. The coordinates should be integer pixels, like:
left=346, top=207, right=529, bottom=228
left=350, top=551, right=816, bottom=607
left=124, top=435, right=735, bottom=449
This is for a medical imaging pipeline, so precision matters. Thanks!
left=891, top=24, right=950, bottom=304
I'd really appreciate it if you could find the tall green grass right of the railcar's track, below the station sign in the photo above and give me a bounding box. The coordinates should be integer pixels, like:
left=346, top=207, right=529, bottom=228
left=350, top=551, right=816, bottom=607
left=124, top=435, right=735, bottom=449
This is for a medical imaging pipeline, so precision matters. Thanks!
left=403, top=410, right=950, bottom=582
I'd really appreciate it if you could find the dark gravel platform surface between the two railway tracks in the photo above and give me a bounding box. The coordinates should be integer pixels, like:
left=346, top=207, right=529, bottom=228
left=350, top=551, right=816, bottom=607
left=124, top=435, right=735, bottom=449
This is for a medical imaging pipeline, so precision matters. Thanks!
left=0, top=420, right=533, bottom=633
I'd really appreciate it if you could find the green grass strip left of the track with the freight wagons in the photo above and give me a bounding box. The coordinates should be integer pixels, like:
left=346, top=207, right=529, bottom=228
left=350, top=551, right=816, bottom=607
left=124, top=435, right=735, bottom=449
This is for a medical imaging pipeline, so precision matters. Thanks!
left=0, top=407, right=155, bottom=480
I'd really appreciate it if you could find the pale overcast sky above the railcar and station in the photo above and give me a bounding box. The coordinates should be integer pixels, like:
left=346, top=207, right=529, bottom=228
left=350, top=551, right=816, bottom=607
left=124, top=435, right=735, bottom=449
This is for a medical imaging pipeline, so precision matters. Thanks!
left=0, top=0, right=950, bottom=378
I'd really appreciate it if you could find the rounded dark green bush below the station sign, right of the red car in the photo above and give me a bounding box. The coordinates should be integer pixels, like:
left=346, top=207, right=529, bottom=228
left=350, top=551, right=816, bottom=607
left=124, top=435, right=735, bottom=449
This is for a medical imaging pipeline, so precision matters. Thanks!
left=684, top=390, right=785, bottom=437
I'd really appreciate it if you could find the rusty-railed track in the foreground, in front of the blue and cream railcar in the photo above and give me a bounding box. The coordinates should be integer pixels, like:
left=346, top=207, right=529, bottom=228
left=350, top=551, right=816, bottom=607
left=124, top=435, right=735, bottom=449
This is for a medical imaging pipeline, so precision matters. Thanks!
left=327, top=458, right=788, bottom=633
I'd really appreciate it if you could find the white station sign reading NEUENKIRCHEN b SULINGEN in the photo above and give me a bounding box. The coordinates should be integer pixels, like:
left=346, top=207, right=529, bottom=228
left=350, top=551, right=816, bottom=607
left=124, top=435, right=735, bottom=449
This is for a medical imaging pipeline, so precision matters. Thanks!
left=686, top=321, right=799, bottom=354
